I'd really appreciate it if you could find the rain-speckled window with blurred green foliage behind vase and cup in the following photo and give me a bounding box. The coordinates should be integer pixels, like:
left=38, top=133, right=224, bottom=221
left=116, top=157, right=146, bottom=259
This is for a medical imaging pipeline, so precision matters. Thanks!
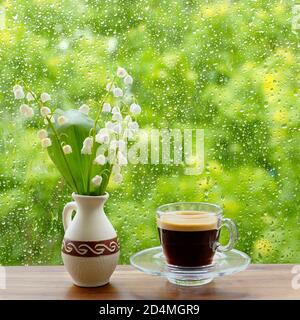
left=0, top=0, right=300, bottom=265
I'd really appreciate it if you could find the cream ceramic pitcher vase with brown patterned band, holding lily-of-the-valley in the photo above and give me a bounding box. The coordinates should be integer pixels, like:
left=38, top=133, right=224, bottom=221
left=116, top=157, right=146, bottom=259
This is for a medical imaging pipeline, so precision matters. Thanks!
left=62, top=193, right=120, bottom=287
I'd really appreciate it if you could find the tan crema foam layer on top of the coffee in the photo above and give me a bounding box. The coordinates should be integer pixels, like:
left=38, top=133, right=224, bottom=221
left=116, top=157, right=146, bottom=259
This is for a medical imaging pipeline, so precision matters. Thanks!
left=157, top=211, right=218, bottom=231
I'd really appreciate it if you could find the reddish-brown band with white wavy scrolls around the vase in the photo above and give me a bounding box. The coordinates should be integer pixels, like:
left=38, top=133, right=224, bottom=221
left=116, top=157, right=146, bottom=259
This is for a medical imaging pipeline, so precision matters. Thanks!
left=61, top=237, right=120, bottom=257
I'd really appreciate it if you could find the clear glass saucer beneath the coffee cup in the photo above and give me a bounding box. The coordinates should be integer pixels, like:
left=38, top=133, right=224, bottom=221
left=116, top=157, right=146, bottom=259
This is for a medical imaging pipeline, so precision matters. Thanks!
left=130, top=247, right=250, bottom=286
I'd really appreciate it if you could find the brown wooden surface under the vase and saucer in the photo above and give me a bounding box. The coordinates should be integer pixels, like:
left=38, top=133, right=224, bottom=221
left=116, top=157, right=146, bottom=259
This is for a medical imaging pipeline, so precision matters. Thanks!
left=0, top=265, right=300, bottom=300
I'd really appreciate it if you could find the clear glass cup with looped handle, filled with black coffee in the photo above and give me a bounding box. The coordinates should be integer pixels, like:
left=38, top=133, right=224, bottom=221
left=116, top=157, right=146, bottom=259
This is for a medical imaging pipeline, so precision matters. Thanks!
left=157, top=202, right=237, bottom=284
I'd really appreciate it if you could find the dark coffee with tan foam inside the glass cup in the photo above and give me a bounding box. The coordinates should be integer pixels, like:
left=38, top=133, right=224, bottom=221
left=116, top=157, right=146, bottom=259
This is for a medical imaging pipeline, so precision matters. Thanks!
left=157, top=211, right=219, bottom=267
